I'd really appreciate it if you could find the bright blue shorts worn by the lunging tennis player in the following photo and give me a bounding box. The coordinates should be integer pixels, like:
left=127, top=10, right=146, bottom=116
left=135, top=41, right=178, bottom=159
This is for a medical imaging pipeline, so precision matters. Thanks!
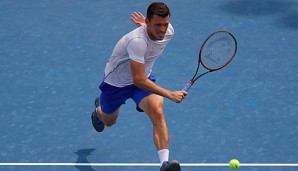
left=99, top=76, right=156, bottom=114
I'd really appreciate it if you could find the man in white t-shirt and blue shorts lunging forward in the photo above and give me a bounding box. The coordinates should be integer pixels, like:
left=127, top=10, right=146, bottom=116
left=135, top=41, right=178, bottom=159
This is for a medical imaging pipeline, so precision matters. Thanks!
left=91, top=2, right=187, bottom=171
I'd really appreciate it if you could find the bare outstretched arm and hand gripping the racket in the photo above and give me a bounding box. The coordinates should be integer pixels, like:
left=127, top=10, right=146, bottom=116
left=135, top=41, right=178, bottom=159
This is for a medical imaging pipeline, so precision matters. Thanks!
left=130, top=60, right=187, bottom=103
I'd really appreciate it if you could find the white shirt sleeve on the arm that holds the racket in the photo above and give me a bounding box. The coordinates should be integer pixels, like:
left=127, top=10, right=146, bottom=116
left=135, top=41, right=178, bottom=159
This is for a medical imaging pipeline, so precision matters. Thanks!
left=127, top=38, right=147, bottom=63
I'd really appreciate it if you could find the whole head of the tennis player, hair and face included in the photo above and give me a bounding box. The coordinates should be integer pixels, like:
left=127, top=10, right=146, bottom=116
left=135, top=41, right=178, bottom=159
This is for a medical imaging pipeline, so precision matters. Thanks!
left=146, top=2, right=171, bottom=40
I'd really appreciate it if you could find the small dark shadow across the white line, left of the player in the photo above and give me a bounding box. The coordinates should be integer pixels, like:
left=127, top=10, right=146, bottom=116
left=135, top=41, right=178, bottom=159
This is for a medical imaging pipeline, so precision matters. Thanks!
left=74, top=148, right=95, bottom=171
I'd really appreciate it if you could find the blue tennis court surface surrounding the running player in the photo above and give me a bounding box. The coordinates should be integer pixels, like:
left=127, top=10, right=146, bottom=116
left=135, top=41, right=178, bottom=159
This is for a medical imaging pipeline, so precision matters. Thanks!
left=0, top=0, right=298, bottom=171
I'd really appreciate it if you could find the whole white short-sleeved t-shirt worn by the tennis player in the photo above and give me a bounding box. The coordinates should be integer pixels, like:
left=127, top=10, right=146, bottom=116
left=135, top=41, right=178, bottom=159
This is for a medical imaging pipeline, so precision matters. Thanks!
left=104, top=24, right=174, bottom=87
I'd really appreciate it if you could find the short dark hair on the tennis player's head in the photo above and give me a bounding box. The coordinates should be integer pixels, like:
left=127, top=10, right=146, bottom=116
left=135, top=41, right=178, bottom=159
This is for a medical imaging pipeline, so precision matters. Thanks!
left=147, top=2, right=171, bottom=21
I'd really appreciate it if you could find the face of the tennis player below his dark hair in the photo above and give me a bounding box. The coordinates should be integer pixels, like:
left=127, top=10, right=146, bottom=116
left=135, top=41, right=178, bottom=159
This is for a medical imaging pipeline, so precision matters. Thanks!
left=146, top=15, right=170, bottom=40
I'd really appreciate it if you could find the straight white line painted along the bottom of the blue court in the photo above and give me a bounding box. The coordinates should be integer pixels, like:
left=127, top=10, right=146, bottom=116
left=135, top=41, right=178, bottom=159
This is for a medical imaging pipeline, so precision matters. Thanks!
left=0, top=163, right=298, bottom=167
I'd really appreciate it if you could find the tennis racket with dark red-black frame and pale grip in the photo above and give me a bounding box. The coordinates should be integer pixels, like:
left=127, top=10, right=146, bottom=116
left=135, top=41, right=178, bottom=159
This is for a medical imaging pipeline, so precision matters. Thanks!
left=182, top=31, right=237, bottom=91
